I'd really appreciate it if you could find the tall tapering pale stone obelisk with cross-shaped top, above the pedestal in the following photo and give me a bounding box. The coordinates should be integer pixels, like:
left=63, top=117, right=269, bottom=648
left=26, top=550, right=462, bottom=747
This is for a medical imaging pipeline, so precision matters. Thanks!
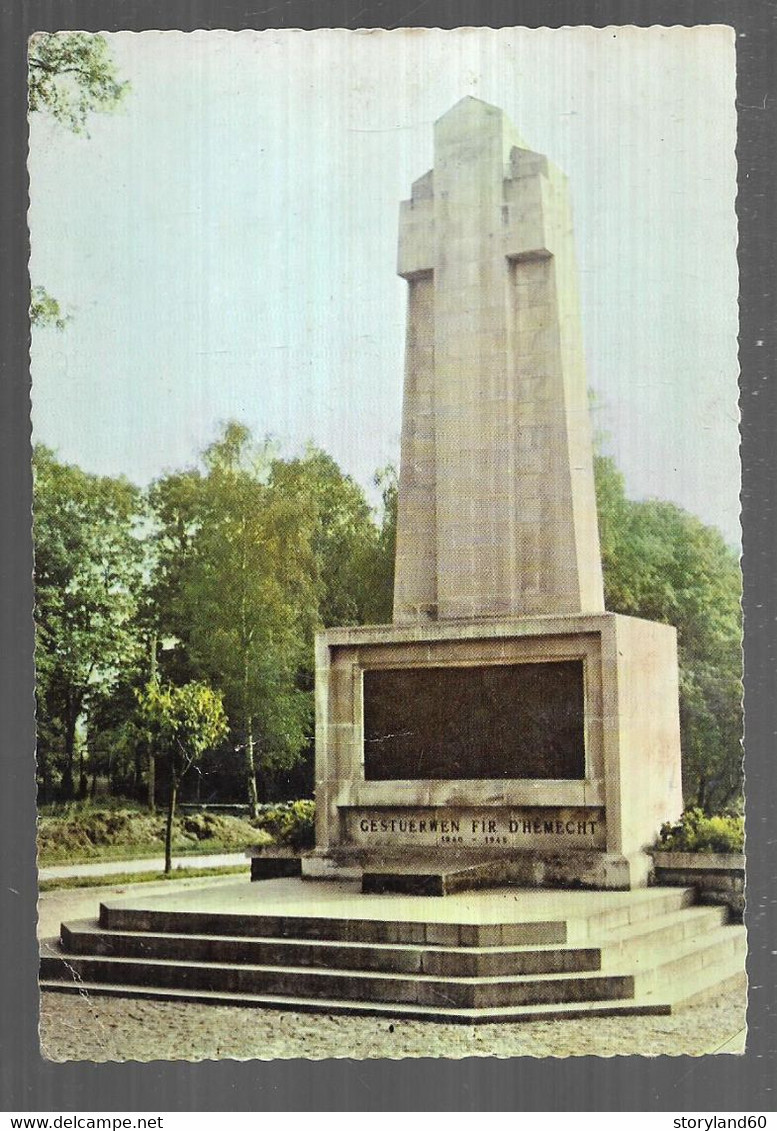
left=394, top=97, right=604, bottom=623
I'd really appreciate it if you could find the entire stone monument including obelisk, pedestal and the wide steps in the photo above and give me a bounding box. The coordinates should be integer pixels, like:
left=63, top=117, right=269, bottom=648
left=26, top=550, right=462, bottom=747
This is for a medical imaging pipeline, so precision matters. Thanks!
left=41, top=98, right=745, bottom=1031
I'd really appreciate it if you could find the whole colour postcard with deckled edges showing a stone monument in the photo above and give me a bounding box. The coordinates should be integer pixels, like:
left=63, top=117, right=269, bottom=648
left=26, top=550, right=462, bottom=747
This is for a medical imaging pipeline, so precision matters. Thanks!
left=28, top=25, right=746, bottom=1061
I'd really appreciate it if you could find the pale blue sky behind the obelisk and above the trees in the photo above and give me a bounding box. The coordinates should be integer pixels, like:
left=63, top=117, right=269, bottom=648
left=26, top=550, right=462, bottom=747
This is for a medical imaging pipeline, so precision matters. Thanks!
left=29, top=27, right=739, bottom=543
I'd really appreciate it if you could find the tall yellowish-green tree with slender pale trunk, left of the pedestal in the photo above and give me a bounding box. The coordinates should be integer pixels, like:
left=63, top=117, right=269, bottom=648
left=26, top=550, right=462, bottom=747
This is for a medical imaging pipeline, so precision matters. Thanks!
left=152, top=423, right=318, bottom=814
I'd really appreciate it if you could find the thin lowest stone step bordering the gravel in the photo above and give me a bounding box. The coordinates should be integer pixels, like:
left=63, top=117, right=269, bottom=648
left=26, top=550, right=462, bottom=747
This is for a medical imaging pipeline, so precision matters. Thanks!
left=40, top=977, right=672, bottom=1025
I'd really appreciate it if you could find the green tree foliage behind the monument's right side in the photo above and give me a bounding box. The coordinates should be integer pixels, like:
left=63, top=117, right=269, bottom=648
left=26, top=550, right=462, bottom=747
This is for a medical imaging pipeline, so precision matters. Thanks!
left=595, top=456, right=742, bottom=812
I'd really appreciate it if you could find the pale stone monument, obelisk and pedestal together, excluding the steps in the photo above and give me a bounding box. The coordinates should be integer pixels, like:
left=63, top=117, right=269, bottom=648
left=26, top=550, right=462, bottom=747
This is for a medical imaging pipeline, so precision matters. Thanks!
left=316, top=98, right=682, bottom=891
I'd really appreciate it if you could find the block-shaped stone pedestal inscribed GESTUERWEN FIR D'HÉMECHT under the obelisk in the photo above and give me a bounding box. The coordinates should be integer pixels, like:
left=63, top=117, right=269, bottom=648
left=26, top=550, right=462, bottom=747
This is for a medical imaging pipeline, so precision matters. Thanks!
left=316, top=613, right=682, bottom=890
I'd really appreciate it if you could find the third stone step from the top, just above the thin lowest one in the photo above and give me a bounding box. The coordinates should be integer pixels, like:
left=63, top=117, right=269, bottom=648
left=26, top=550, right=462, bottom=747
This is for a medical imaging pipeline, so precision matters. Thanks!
left=41, top=950, right=633, bottom=1009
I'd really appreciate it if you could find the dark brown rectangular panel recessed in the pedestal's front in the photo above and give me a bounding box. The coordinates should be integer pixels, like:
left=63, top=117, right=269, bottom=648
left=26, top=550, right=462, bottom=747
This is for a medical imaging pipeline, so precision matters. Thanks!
left=364, top=661, right=585, bottom=782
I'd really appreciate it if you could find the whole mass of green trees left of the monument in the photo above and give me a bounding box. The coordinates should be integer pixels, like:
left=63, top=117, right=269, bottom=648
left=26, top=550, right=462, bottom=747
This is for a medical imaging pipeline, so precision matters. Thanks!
left=35, top=423, right=396, bottom=810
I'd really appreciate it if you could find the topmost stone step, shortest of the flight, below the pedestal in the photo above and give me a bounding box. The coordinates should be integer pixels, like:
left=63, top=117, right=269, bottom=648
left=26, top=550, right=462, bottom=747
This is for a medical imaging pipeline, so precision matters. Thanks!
left=100, top=904, right=567, bottom=947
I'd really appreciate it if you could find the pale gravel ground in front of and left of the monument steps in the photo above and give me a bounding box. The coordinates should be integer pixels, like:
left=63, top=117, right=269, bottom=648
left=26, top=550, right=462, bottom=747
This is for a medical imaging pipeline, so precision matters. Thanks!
left=38, top=877, right=745, bottom=1061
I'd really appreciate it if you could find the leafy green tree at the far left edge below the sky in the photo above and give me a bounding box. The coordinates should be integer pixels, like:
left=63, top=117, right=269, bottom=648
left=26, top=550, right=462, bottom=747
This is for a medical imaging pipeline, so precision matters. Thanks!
left=33, top=444, right=143, bottom=798
